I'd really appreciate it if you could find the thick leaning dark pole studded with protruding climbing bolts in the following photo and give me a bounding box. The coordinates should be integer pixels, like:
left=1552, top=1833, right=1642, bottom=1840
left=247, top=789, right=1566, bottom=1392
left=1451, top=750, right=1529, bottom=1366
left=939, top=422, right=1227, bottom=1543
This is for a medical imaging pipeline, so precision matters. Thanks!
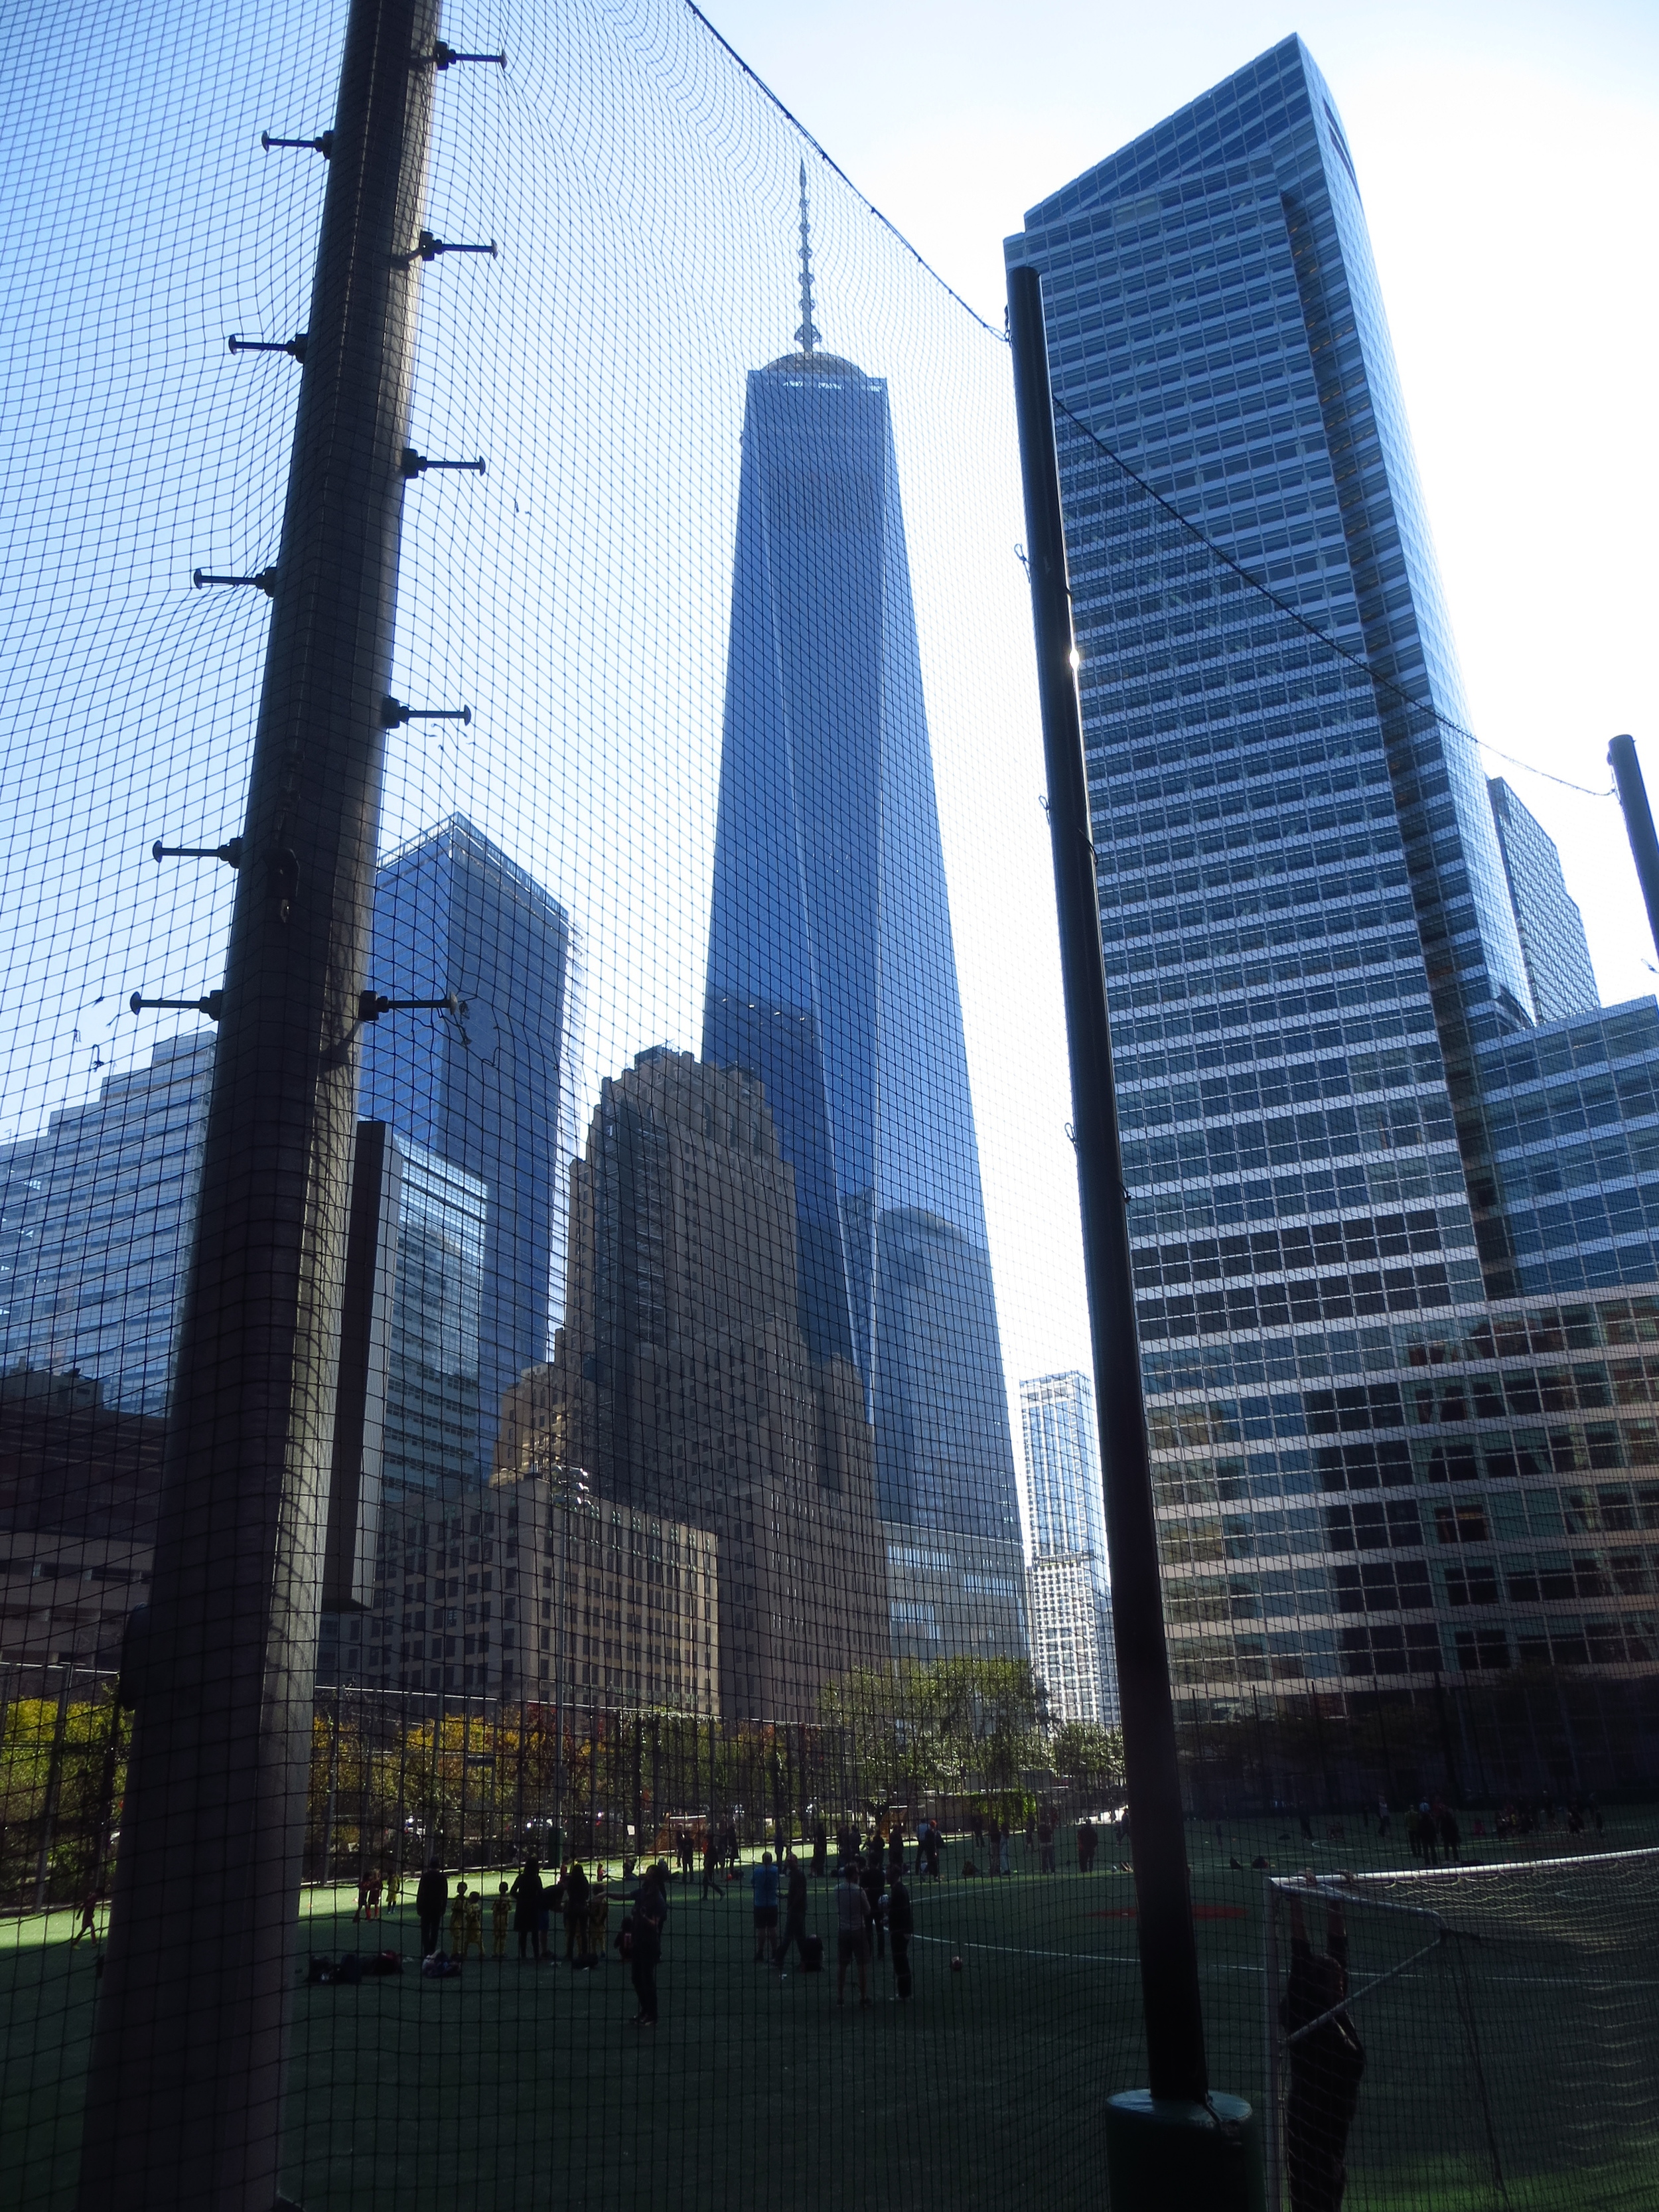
left=80, top=0, right=438, bottom=2212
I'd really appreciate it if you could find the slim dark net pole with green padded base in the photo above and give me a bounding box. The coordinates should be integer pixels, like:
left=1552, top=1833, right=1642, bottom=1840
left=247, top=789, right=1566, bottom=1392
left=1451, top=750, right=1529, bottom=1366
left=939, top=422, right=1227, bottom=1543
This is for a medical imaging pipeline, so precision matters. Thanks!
left=1009, top=267, right=1263, bottom=2212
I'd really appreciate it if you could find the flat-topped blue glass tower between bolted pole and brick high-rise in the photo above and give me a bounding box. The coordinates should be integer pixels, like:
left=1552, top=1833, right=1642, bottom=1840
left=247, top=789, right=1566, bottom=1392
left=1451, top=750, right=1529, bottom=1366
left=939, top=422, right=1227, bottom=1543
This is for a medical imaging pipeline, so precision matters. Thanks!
left=358, top=816, right=575, bottom=1482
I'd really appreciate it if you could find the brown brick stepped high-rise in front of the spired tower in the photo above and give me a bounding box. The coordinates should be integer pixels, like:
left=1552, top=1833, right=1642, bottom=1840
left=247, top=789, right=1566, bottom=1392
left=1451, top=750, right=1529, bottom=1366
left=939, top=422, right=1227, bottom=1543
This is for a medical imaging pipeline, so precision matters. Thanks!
left=540, top=1049, right=887, bottom=1721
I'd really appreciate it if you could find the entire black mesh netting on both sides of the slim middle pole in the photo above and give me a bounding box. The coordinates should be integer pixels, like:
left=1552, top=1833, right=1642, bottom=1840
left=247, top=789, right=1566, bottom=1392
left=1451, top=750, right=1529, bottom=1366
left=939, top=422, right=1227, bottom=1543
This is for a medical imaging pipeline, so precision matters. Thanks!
left=0, top=0, right=1659, bottom=2212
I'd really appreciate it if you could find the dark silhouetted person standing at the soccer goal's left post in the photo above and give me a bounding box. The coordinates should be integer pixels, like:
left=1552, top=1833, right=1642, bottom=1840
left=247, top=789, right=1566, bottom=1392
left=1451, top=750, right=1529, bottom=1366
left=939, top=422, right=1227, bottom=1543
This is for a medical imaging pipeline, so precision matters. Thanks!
left=1279, top=1891, right=1365, bottom=2212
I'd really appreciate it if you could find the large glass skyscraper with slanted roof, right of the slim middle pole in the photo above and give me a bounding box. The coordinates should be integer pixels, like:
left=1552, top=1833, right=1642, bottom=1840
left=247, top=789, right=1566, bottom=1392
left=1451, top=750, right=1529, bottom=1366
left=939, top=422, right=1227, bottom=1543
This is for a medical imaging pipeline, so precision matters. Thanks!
left=1009, top=38, right=1659, bottom=1706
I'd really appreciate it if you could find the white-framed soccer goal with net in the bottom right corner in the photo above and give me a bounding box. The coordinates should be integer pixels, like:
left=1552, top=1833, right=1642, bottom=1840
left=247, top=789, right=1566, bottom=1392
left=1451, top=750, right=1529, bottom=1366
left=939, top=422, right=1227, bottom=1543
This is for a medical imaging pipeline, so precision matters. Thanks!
left=1263, top=1852, right=1659, bottom=2212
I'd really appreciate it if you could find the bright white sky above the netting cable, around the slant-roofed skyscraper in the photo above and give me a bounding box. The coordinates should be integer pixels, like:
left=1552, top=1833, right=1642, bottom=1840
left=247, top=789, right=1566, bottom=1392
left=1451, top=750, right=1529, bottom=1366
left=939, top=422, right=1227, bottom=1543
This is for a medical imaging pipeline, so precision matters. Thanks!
left=712, top=0, right=1659, bottom=1002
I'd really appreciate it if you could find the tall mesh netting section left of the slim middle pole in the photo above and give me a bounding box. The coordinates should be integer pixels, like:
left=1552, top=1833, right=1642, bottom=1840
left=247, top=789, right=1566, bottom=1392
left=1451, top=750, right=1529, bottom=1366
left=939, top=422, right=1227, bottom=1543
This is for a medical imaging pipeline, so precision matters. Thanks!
left=0, top=0, right=1168, bottom=2207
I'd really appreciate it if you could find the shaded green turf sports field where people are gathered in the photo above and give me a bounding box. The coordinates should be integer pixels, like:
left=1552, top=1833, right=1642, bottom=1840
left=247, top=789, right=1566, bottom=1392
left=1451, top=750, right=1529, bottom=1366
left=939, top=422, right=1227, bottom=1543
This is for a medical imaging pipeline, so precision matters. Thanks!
left=0, top=1814, right=1659, bottom=2212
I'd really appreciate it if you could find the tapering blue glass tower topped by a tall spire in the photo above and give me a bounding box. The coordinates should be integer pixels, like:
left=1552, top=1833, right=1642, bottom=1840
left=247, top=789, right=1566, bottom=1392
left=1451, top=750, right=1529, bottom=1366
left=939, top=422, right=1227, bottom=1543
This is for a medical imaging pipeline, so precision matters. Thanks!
left=703, top=186, right=1024, bottom=1657
